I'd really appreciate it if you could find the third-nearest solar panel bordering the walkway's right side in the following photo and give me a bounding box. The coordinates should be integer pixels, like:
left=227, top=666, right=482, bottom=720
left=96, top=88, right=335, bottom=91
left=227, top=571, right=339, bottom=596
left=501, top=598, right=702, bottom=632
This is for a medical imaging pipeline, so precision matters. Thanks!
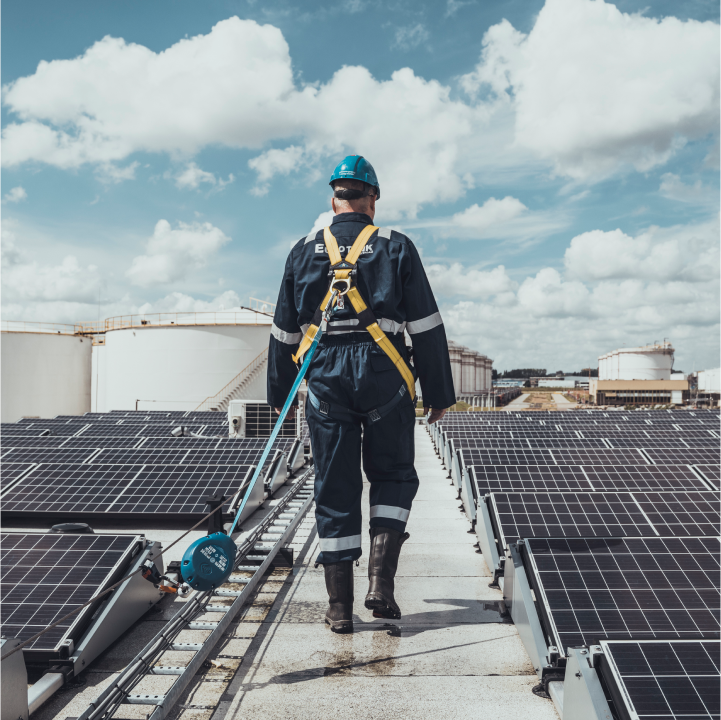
left=489, top=492, right=654, bottom=547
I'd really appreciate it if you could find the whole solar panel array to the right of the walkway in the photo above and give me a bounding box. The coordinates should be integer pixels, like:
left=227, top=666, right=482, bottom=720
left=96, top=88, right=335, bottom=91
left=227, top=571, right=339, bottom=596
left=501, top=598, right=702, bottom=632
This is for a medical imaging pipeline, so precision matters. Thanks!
left=431, top=410, right=721, bottom=718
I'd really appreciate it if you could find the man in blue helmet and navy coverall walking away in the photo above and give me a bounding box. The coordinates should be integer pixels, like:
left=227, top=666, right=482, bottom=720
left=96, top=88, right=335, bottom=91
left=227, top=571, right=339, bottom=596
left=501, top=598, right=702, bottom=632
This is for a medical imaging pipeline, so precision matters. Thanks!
left=268, top=155, right=455, bottom=632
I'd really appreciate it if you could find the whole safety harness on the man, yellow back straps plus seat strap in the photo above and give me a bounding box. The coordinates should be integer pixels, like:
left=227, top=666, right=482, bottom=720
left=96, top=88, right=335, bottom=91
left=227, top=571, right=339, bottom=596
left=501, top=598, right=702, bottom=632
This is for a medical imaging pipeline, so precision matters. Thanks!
left=293, top=225, right=416, bottom=422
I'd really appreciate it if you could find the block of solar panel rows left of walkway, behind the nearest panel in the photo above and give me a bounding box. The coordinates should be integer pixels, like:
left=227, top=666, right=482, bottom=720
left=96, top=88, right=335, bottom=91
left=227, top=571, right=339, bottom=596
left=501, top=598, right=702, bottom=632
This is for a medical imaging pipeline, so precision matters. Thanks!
left=0, top=411, right=302, bottom=522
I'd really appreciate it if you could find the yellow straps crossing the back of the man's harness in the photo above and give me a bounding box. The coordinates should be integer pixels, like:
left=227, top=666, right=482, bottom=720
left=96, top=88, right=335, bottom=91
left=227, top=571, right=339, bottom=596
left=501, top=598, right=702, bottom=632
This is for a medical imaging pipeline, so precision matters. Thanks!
left=293, top=225, right=416, bottom=398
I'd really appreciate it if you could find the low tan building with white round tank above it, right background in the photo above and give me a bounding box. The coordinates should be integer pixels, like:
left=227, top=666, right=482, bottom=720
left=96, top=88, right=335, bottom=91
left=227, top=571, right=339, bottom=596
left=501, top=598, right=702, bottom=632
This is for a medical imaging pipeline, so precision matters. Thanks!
left=589, top=342, right=689, bottom=406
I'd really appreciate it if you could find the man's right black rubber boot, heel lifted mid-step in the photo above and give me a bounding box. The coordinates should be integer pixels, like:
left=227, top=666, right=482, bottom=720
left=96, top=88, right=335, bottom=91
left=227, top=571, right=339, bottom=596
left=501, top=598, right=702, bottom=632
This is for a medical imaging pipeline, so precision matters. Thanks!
left=365, top=527, right=410, bottom=620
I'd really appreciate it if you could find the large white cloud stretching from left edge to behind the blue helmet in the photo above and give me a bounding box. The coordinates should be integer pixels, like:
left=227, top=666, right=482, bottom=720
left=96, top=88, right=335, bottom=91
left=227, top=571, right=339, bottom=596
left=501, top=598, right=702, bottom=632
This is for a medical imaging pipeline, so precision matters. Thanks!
left=0, top=18, right=492, bottom=218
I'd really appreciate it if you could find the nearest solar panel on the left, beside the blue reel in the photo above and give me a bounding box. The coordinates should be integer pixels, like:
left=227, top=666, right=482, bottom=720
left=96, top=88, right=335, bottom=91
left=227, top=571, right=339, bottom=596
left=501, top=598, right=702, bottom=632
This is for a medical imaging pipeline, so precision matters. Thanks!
left=0, top=533, right=139, bottom=657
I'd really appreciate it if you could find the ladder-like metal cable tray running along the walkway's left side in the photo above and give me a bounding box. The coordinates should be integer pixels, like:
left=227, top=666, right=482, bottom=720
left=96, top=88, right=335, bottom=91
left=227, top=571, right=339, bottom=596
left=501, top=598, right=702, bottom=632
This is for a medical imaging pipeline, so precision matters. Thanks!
left=77, top=470, right=313, bottom=720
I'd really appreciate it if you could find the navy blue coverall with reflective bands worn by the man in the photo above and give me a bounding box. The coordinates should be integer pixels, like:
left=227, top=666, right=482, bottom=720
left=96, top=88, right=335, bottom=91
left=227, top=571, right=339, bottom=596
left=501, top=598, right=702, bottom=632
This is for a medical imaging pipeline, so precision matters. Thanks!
left=268, top=213, right=456, bottom=563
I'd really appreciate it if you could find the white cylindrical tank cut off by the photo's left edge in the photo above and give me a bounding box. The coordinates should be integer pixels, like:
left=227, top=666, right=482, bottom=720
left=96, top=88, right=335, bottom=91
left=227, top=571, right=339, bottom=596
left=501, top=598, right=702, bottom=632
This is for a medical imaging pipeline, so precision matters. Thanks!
left=0, top=323, right=92, bottom=422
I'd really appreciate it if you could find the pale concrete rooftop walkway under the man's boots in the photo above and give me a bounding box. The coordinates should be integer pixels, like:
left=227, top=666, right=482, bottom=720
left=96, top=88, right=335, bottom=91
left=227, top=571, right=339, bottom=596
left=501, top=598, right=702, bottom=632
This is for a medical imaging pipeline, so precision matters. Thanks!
left=211, top=426, right=558, bottom=720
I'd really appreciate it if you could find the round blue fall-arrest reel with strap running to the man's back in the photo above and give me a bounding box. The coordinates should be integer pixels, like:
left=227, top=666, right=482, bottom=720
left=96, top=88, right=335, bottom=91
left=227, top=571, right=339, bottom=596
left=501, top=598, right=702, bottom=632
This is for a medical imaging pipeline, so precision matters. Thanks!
left=180, top=290, right=343, bottom=591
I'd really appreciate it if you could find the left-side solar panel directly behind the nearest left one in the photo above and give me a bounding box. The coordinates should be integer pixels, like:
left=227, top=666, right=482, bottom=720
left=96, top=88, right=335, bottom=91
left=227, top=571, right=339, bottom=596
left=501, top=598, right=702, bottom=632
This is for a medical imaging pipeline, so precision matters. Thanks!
left=0, top=463, right=252, bottom=520
